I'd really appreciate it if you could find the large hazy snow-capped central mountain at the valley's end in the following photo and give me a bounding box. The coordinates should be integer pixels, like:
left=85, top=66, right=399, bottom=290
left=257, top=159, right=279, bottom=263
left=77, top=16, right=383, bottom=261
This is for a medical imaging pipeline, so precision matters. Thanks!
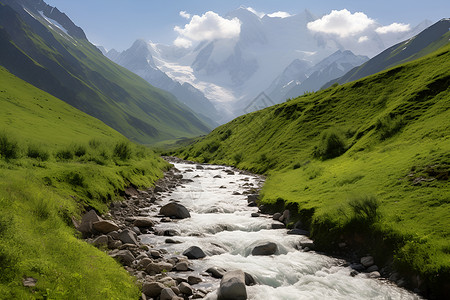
left=108, top=7, right=427, bottom=122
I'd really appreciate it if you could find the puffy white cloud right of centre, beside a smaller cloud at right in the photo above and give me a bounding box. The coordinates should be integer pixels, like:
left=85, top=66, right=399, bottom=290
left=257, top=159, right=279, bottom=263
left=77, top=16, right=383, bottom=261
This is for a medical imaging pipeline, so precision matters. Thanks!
left=307, top=9, right=375, bottom=37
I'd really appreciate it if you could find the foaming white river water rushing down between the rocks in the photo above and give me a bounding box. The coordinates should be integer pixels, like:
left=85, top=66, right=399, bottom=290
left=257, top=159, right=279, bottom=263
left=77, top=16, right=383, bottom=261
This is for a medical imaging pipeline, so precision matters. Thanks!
left=141, top=163, right=420, bottom=300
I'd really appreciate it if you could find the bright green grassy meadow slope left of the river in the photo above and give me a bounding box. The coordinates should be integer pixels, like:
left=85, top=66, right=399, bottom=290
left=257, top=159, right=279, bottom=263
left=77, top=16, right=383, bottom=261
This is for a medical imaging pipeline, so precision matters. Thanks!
left=0, top=67, right=167, bottom=299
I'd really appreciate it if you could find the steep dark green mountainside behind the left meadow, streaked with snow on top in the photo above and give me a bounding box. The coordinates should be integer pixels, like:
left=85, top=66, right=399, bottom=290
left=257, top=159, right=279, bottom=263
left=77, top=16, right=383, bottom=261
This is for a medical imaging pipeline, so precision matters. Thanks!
left=0, top=0, right=210, bottom=144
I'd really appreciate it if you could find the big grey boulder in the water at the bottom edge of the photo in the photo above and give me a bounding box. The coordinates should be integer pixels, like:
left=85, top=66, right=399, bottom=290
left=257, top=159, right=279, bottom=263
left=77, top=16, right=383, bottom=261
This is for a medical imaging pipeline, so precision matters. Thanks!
left=217, top=270, right=247, bottom=300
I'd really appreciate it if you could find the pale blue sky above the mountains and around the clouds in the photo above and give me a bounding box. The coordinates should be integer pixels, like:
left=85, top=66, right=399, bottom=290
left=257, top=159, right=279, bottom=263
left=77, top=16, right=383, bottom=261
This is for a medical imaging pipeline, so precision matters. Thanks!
left=45, top=0, right=450, bottom=50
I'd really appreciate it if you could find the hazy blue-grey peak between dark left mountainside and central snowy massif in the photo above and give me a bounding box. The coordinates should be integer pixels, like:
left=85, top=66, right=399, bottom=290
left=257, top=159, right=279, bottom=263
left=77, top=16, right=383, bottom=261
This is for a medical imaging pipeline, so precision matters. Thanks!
left=107, top=40, right=219, bottom=127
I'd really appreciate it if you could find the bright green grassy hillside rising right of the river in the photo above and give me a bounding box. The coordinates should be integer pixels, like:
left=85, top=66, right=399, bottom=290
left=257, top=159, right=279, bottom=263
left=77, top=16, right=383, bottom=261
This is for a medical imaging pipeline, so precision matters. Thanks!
left=179, top=45, right=450, bottom=296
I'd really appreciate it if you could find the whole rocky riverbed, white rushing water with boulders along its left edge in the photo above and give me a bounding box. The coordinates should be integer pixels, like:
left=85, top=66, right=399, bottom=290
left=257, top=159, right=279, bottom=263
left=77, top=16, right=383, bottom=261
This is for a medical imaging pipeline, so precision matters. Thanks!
left=77, top=158, right=419, bottom=300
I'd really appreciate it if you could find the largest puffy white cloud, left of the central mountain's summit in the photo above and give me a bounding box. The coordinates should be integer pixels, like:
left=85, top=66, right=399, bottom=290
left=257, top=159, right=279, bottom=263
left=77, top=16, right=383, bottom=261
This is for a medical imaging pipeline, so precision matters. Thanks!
left=174, top=11, right=241, bottom=47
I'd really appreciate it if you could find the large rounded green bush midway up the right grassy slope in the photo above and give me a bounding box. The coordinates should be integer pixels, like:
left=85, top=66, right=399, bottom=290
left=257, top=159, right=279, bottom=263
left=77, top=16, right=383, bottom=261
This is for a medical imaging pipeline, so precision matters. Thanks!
left=313, top=129, right=347, bottom=159
